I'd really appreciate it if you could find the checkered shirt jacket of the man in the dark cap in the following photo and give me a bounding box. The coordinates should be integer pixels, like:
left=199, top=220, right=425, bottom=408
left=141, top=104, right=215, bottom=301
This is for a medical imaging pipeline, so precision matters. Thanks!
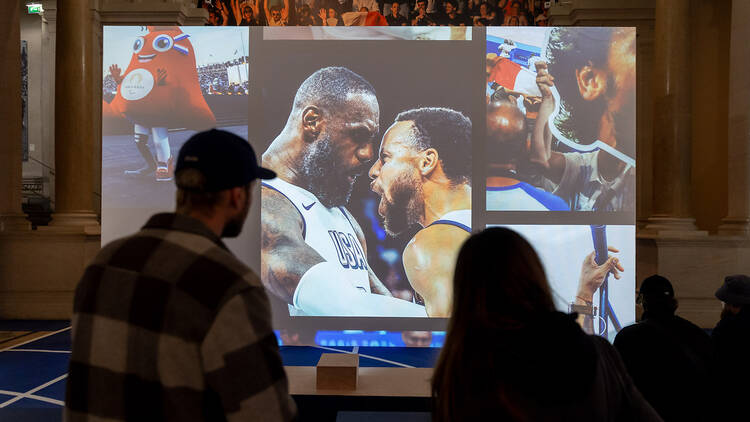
left=64, top=214, right=296, bottom=422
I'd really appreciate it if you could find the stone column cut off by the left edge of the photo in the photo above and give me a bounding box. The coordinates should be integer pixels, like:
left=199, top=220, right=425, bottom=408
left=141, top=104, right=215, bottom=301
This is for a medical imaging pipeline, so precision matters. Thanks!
left=0, top=1, right=30, bottom=232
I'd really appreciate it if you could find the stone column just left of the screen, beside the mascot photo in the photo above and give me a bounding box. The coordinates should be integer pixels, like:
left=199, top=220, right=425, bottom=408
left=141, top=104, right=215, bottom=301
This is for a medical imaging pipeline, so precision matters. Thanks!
left=51, top=0, right=99, bottom=226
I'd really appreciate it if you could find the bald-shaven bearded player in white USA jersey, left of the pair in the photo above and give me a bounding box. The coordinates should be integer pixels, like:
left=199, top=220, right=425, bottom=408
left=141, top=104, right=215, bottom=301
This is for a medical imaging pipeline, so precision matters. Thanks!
left=261, top=67, right=426, bottom=317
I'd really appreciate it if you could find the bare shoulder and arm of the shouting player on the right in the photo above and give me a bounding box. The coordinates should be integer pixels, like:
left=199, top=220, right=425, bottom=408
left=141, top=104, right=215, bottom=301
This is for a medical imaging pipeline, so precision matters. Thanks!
left=403, top=224, right=469, bottom=317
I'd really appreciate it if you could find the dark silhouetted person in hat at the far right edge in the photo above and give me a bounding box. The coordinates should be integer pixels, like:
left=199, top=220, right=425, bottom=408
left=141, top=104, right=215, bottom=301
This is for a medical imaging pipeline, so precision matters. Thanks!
left=711, top=275, right=750, bottom=420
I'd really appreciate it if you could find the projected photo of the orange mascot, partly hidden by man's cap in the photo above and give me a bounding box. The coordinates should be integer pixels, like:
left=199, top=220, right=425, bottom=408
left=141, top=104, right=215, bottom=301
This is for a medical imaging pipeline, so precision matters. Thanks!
left=102, top=26, right=249, bottom=242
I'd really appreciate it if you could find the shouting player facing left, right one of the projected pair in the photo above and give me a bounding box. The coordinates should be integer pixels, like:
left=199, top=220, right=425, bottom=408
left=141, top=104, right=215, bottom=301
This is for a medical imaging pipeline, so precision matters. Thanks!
left=369, top=107, right=471, bottom=317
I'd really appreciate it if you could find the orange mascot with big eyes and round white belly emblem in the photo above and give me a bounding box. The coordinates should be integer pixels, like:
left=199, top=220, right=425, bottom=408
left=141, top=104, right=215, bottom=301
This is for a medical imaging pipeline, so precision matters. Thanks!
left=105, top=26, right=216, bottom=181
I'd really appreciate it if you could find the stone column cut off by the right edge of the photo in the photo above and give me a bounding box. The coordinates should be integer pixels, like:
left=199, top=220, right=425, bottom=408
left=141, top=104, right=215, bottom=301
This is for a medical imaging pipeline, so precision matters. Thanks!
left=719, top=1, right=750, bottom=236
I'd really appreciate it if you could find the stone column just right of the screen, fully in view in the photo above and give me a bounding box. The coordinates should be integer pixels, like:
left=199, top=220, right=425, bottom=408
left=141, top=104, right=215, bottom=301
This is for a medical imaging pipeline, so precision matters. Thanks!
left=646, top=0, right=705, bottom=234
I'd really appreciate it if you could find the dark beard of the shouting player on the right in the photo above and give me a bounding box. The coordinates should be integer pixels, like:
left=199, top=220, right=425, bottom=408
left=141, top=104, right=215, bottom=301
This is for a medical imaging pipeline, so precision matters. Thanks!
left=382, top=173, right=424, bottom=237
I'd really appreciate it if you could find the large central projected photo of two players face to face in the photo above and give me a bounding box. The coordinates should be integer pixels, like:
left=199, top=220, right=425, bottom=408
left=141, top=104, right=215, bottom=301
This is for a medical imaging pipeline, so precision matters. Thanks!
left=252, top=33, right=472, bottom=317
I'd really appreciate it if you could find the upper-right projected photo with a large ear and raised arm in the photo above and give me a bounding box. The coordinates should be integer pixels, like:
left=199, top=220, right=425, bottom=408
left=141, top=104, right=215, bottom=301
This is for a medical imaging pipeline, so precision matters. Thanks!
left=486, top=27, right=635, bottom=213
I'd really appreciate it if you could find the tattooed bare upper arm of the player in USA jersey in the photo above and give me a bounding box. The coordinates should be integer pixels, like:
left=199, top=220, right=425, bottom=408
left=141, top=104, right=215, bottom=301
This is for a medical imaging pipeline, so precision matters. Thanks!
left=260, top=186, right=324, bottom=304
